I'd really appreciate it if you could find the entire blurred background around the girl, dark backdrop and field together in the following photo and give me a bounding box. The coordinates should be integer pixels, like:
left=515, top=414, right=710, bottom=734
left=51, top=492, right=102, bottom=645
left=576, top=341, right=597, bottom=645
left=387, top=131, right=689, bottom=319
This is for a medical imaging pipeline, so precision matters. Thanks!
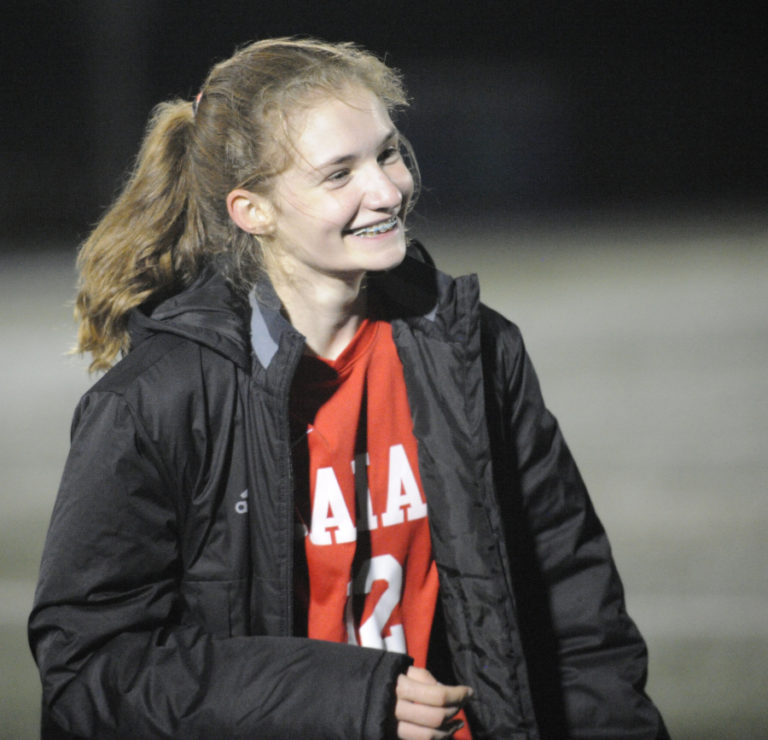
left=0, top=0, right=768, bottom=740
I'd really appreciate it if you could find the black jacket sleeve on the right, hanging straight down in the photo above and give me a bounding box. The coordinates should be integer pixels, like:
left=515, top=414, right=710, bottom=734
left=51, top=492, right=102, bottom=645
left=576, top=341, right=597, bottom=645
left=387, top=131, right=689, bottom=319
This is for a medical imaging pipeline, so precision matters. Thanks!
left=484, top=309, right=667, bottom=739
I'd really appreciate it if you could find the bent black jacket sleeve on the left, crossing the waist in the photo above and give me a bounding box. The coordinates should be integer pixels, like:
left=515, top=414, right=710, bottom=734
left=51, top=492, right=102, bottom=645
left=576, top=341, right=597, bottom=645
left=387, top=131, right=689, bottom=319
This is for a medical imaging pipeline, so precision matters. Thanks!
left=29, top=392, right=409, bottom=738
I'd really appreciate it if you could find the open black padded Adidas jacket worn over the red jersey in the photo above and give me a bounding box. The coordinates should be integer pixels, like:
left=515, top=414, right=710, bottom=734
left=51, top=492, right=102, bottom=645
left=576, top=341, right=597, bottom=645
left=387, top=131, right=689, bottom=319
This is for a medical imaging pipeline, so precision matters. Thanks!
left=30, top=246, right=664, bottom=740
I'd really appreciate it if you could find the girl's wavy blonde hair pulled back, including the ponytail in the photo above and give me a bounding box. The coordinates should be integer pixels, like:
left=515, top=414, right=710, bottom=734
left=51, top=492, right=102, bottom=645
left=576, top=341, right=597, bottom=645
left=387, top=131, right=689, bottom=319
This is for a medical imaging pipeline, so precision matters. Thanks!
left=75, top=38, right=415, bottom=370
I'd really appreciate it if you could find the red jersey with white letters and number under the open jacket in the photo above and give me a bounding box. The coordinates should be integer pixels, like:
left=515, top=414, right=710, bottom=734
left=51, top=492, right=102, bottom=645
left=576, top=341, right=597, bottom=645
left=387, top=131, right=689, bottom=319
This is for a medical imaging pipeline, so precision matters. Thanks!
left=291, top=320, right=471, bottom=740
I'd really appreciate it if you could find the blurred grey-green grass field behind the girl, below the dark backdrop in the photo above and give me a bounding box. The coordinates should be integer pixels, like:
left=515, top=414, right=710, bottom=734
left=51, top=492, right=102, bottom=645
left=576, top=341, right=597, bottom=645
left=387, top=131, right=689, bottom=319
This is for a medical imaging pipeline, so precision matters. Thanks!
left=0, top=214, right=768, bottom=740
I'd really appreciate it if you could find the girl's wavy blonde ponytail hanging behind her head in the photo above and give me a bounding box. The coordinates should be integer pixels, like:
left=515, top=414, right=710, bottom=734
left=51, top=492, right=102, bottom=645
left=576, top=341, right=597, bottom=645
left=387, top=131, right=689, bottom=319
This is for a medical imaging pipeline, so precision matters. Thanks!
left=75, top=100, right=202, bottom=371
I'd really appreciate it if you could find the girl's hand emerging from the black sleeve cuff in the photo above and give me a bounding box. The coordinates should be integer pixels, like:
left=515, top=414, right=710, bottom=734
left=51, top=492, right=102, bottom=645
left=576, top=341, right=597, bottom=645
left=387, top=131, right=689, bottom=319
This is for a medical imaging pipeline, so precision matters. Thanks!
left=395, top=666, right=472, bottom=740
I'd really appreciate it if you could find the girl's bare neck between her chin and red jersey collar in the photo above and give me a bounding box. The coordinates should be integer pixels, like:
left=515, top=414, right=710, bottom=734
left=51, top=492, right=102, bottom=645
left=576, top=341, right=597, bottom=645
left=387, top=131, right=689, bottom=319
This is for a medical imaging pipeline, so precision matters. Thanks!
left=270, top=272, right=366, bottom=360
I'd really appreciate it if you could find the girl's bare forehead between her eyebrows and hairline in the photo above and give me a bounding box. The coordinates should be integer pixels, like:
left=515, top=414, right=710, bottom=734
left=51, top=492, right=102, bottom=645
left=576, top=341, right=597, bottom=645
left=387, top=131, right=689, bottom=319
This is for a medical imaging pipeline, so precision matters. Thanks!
left=286, top=87, right=394, bottom=167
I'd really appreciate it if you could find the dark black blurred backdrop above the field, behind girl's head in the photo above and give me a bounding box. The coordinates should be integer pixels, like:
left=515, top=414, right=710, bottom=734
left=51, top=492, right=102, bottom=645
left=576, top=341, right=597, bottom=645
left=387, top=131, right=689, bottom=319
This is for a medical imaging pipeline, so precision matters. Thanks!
left=0, top=0, right=768, bottom=236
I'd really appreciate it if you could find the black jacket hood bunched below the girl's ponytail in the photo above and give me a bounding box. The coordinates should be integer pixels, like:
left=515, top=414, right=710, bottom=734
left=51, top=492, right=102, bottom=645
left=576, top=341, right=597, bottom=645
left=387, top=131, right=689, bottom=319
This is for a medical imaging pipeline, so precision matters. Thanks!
left=128, top=270, right=249, bottom=366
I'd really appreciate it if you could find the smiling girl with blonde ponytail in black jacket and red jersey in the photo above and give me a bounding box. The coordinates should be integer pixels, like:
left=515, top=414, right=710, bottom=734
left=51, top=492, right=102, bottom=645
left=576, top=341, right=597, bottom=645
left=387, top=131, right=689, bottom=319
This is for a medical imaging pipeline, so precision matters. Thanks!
left=30, top=39, right=664, bottom=740
